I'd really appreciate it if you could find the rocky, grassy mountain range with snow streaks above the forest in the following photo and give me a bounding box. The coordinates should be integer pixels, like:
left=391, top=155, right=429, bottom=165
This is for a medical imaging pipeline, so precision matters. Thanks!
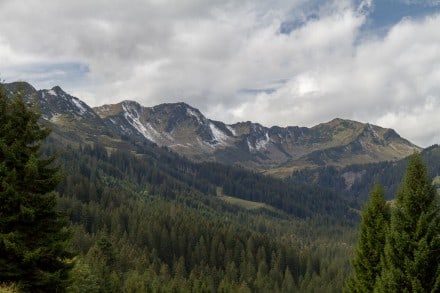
left=4, top=82, right=420, bottom=177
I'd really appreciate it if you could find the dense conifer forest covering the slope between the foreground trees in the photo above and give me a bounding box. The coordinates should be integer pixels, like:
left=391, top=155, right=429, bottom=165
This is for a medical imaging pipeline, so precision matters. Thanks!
left=55, top=146, right=354, bottom=292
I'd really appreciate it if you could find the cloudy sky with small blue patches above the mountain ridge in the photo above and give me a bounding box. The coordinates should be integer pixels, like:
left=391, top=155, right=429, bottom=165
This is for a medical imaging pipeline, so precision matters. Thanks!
left=0, top=0, right=440, bottom=147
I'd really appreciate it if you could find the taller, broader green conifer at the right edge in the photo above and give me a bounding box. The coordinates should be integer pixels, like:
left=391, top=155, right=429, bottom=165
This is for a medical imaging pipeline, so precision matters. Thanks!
left=375, top=154, right=440, bottom=292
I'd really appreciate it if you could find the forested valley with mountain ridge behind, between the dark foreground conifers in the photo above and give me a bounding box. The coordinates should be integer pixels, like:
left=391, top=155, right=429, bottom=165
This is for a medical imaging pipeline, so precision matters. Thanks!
left=4, top=83, right=440, bottom=292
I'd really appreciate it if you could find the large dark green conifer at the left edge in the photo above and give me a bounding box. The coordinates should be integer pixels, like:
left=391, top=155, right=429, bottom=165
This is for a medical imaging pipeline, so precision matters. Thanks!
left=0, top=85, right=72, bottom=292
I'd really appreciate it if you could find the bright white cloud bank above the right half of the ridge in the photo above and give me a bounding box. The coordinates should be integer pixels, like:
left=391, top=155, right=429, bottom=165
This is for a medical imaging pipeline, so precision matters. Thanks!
left=220, top=12, right=440, bottom=146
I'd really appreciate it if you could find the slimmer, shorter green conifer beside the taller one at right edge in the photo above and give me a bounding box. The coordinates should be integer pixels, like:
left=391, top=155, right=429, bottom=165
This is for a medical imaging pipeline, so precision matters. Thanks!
left=346, top=185, right=389, bottom=292
